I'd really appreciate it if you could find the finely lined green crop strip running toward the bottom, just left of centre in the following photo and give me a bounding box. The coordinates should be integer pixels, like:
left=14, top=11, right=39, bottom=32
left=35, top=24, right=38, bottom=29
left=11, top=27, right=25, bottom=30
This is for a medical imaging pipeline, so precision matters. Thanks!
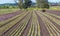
left=11, top=11, right=30, bottom=36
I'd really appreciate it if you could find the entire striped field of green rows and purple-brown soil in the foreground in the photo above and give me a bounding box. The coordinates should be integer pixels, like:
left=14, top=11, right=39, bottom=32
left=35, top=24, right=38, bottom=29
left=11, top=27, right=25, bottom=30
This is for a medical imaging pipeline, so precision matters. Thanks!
left=0, top=10, right=60, bottom=36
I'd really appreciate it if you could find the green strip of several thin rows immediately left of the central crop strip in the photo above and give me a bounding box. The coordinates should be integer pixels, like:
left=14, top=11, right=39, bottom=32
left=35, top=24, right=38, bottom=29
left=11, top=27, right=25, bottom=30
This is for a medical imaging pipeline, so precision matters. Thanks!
left=11, top=11, right=31, bottom=36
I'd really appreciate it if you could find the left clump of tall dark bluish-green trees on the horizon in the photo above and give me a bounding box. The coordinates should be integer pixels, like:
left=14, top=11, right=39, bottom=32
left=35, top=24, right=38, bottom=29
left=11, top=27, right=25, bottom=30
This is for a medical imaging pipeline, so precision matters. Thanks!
left=15, top=0, right=32, bottom=9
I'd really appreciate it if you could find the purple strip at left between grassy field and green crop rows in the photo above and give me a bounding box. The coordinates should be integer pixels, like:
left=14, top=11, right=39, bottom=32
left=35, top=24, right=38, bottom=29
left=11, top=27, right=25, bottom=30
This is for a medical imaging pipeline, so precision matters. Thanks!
left=0, top=11, right=22, bottom=21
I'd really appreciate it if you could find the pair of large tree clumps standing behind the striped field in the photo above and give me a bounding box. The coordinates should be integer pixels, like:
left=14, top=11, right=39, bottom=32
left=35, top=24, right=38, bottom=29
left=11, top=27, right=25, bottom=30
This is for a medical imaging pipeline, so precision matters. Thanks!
left=18, top=0, right=49, bottom=9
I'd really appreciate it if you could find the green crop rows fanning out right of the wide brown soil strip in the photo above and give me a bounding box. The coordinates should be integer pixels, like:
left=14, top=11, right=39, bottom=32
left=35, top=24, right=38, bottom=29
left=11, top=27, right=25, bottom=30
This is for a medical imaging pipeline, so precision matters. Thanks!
left=38, top=12, right=60, bottom=36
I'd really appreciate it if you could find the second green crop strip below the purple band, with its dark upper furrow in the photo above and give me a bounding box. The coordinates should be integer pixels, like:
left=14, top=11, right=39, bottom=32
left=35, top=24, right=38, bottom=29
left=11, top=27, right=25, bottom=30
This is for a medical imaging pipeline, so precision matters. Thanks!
left=0, top=12, right=28, bottom=34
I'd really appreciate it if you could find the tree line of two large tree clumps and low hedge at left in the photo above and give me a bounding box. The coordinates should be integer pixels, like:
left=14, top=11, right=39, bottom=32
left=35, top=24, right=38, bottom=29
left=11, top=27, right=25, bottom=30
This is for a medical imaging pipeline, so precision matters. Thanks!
left=0, top=0, right=49, bottom=9
